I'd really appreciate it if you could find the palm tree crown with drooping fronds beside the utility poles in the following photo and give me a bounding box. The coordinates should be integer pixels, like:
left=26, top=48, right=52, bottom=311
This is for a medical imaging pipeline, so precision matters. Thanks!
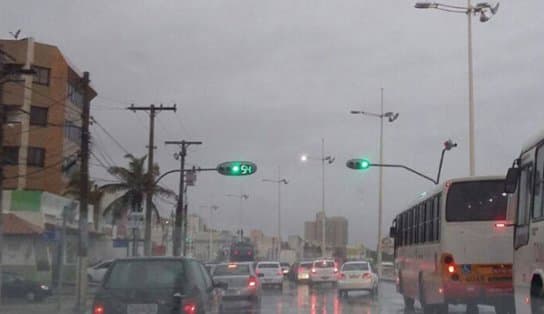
left=100, top=154, right=176, bottom=228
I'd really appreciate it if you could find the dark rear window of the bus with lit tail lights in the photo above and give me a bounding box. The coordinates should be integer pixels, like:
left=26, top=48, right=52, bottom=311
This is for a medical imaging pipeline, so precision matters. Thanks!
left=446, top=180, right=507, bottom=222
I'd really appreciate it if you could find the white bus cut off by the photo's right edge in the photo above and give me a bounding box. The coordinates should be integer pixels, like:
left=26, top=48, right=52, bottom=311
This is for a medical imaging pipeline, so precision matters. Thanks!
left=505, top=134, right=544, bottom=314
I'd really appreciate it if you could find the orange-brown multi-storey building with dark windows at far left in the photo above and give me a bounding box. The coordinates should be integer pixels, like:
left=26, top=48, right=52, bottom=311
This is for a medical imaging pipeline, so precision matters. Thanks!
left=0, top=38, right=96, bottom=195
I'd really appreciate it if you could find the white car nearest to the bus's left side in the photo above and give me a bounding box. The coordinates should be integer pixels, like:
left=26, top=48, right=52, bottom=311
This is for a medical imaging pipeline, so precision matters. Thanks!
left=337, top=261, right=378, bottom=297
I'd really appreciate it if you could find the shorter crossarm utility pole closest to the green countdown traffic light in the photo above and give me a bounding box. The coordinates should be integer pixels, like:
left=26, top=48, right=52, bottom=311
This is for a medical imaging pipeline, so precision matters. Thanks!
left=164, top=140, right=202, bottom=256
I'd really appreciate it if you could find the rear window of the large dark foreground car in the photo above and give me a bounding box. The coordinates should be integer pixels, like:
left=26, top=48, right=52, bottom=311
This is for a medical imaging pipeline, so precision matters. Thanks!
left=104, top=260, right=185, bottom=289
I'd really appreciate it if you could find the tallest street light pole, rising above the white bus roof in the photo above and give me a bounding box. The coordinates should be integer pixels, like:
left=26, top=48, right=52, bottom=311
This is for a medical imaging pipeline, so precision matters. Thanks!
left=415, top=0, right=499, bottom=176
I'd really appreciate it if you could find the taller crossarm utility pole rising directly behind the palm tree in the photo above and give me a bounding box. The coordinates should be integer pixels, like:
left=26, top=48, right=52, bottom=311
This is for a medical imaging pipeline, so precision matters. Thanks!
left=127, top=104, right=176, bottom=256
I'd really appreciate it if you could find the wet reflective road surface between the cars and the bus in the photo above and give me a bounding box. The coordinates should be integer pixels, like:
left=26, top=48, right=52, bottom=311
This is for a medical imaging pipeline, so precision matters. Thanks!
left=219, top=282, right=495, bottom=314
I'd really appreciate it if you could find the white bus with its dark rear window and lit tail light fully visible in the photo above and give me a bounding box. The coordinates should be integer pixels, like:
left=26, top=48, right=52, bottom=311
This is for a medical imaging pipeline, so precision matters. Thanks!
left=390, top=177, right=514, bottom=313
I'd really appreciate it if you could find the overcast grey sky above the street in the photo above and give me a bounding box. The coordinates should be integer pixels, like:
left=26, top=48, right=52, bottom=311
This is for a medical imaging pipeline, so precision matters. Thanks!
left=0, top=0, right=544, bottom=246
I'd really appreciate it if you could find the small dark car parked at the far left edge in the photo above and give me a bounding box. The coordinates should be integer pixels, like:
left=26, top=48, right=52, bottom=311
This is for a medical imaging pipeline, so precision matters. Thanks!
left=2, top=272, right=52, bottom=302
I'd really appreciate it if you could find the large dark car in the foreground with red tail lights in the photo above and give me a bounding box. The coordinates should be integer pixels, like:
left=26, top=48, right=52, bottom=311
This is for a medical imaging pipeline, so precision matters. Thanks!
left=93, top=257, right=226, bottom=314
